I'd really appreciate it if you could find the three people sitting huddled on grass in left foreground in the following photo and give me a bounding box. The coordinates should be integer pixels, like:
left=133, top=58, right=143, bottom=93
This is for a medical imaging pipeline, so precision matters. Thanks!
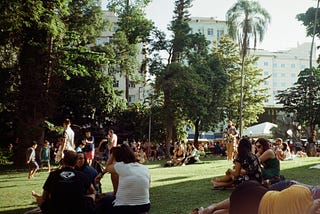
left=30, top=144, right=150, bottom=214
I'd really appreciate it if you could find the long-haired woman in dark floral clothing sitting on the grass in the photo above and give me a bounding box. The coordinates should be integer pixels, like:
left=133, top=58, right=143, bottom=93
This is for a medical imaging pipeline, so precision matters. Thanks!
left=211, top=138, right=262, bottom=189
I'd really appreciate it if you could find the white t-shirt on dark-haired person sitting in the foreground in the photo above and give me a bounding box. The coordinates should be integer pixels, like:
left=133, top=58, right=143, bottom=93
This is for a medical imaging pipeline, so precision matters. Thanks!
left=113, top=162, right=150, bottom=206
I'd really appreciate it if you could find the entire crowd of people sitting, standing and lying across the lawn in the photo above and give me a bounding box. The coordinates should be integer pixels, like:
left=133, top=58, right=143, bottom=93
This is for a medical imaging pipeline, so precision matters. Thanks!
left=23, top=119, right=320, bottom=214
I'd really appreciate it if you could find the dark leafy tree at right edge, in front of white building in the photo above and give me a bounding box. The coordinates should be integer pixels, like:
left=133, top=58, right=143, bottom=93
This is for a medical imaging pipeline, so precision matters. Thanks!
left=277, top=68, right=320, bottom=130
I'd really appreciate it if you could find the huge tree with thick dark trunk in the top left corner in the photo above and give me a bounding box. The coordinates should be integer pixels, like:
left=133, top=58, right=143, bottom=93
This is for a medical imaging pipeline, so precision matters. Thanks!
left=0, top=0, right=115, bottom=164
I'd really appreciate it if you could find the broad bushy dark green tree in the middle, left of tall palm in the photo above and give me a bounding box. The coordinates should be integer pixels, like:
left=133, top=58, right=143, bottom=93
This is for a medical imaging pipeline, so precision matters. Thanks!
left=173, top=34, right=228, bottom=145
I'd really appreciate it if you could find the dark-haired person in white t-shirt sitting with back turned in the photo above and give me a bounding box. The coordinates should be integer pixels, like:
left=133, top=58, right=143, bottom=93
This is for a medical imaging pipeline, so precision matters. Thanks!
left=96, top=144, right=151, bottom=214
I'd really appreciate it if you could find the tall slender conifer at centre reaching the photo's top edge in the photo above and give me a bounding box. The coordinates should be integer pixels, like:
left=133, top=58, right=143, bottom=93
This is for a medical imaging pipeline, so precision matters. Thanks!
left=150, top=0, right=191, bottom=152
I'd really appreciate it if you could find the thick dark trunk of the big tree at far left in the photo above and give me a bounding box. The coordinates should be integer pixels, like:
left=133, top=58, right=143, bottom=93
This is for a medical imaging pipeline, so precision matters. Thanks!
left=14, top=41, right=50, bottom=166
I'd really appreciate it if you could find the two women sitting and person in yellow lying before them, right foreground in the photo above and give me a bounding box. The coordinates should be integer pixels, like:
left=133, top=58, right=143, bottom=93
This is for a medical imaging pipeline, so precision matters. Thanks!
left=191, top=138, right=320, bottom=214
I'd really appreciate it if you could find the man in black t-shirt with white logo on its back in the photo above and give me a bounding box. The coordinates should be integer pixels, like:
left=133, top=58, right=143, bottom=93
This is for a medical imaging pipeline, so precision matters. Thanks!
left=41, top=151, right=94, bottom=214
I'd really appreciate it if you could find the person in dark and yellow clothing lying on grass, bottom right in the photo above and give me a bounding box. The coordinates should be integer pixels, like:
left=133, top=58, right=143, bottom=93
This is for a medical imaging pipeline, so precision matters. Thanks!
left=191, top=180, right=320, bottom=214
